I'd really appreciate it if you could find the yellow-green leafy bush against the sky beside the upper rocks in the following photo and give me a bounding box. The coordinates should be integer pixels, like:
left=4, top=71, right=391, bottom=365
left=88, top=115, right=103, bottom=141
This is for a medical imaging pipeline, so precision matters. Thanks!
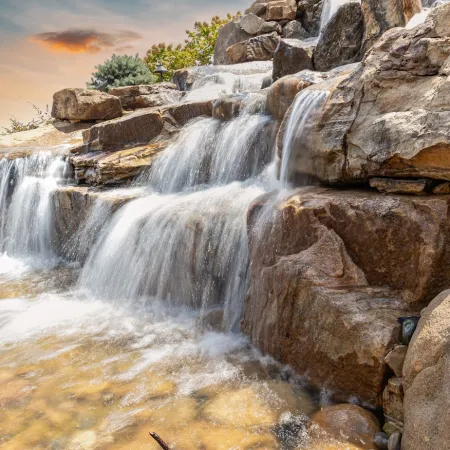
left=144, top=12, right=241, bottom=81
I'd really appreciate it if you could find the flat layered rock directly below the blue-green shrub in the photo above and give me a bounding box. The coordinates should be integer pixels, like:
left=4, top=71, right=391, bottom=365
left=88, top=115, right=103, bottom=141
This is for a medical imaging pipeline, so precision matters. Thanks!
left=109, top=83, right=184, bottom=109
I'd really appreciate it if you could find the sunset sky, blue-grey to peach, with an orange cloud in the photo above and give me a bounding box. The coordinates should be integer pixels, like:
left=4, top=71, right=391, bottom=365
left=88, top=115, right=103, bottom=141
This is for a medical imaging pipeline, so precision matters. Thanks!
left=0, top=0, right=246, bottom=127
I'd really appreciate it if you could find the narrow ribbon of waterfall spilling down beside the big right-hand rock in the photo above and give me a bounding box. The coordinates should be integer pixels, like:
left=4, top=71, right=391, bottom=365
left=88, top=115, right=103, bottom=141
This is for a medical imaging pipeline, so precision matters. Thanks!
left=280, top=89, right=329, bottom=187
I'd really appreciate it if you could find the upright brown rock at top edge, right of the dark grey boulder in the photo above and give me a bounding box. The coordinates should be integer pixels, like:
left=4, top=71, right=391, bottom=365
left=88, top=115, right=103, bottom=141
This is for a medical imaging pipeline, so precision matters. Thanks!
left=361, top=0, right=422, bottom=51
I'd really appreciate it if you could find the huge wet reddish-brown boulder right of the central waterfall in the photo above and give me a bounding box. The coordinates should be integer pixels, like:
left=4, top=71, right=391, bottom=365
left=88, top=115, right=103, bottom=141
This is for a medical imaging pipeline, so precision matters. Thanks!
left=243, top=187, right=450, bottom=405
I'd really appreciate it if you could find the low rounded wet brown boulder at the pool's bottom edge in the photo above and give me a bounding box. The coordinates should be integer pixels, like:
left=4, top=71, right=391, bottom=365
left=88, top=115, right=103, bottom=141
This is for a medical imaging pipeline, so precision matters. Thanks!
left=311, top=404, right=380, bottom=450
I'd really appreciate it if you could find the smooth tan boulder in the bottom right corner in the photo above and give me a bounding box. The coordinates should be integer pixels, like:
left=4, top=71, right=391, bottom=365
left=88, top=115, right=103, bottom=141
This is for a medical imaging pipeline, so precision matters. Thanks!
left=402, top=291, right=450, bottom=450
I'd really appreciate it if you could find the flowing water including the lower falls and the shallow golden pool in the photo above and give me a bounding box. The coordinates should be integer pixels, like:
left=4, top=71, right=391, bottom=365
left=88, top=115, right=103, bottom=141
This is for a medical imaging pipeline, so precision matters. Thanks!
left=0, top=82, right=352, bottom=450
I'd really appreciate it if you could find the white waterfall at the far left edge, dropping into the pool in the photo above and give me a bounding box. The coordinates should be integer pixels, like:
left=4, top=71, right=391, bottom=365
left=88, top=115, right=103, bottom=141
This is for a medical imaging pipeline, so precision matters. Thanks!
left=0, top=151, right=65, bottom=266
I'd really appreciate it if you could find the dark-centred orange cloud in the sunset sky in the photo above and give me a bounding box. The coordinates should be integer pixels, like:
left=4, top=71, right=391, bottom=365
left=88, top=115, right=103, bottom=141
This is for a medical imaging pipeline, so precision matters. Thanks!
left=29, top=29, right=142, bottom=53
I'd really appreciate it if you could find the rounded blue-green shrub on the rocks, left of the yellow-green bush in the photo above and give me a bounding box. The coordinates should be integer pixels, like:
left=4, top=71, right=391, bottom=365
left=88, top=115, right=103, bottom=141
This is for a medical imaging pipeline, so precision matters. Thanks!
left=88, top=55, right=155, bottom=91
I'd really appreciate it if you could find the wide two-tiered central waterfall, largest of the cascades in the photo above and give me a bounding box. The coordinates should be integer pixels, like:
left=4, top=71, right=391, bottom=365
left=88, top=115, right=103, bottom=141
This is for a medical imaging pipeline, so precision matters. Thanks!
left=79, top=98, right=275, bottom=329
